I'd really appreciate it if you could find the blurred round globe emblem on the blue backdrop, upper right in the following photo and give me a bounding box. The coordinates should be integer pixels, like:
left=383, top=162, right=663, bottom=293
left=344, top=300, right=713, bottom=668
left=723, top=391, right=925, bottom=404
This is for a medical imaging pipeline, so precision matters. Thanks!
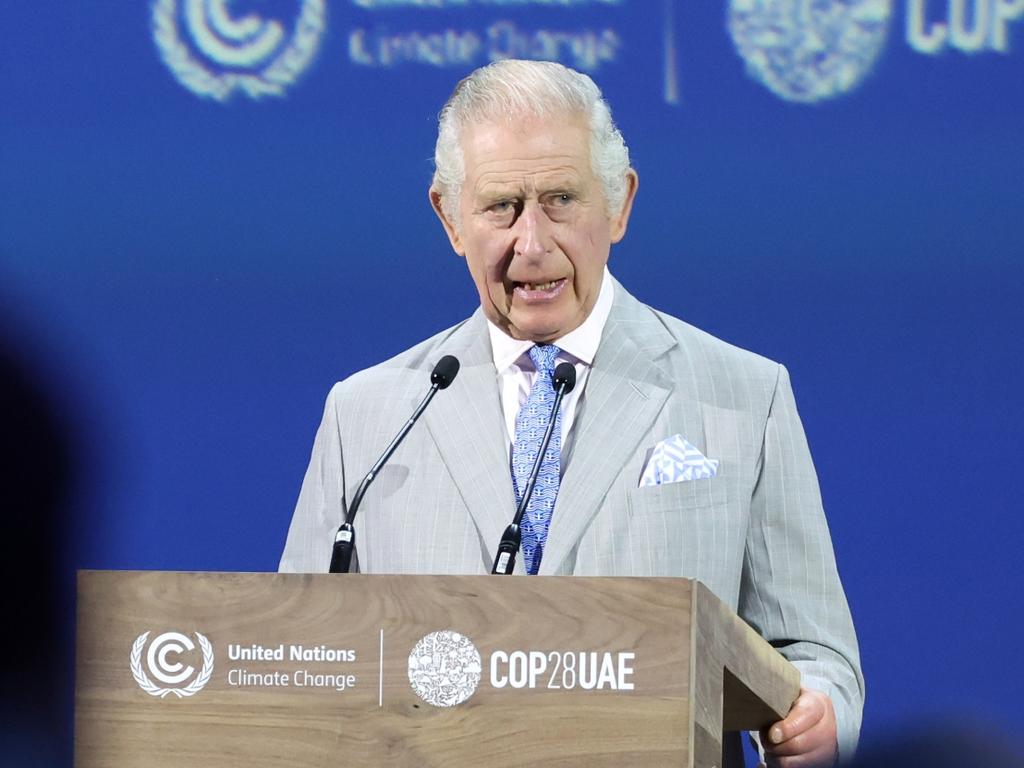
left=728, top=0, right=892, bottom=103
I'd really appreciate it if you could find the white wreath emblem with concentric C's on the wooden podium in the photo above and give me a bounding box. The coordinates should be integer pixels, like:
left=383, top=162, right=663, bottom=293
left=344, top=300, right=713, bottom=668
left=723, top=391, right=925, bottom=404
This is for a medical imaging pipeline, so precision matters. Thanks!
left=129, top=632, right=213, bottom=698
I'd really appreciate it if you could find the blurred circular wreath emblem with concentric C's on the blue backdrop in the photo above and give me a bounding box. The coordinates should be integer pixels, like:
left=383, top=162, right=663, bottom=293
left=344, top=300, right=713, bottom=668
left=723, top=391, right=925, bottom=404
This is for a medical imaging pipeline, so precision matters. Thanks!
left=153, top=0, right=327, bottom=101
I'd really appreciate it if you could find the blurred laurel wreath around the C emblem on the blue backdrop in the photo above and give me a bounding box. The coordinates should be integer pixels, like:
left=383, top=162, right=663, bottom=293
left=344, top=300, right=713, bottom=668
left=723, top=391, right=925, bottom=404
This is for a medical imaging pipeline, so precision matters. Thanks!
left=153, top=0, right=327, bottom=101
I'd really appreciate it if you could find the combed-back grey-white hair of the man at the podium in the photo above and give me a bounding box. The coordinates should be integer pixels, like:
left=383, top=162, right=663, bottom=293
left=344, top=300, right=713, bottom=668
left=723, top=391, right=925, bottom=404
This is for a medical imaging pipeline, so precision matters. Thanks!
left=433, top=58, right=630, bottom=226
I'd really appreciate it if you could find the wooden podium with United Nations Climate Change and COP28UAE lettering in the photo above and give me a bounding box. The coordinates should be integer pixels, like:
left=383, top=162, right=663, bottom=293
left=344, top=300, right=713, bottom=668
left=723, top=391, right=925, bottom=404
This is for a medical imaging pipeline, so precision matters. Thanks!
left=75, top=571, right=800, bottom=768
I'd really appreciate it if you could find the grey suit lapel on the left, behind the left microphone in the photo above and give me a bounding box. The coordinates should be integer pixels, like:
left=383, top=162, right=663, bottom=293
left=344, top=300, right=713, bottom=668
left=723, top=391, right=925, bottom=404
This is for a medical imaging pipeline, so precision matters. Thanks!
left=424, top=310, right=515, bottom=568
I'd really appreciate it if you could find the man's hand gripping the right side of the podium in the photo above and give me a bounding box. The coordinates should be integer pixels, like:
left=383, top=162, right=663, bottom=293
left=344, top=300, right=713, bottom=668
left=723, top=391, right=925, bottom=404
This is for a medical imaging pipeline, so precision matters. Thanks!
left=761, top=688, right=838, bottom=768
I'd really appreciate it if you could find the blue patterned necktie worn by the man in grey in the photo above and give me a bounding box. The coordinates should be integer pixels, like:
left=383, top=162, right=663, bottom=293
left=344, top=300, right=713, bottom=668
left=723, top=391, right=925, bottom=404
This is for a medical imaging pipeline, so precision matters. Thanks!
left=512, top=344, right=562, bottom=573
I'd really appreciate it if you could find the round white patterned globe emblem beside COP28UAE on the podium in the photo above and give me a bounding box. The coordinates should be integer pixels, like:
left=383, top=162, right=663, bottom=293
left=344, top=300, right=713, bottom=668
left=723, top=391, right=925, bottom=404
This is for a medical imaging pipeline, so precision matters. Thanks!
left=409, top=630, right=483, bottom=707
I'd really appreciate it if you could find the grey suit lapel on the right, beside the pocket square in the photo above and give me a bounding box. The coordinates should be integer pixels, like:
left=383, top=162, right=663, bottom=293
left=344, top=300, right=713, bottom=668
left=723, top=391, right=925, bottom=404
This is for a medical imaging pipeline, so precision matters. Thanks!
left=540, top=283, right=676, bottom=574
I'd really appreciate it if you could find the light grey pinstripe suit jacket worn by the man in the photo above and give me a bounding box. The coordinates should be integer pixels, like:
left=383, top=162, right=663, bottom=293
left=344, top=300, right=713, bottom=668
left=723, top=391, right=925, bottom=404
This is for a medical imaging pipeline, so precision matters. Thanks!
left=280, top=283, right=863, bottom=756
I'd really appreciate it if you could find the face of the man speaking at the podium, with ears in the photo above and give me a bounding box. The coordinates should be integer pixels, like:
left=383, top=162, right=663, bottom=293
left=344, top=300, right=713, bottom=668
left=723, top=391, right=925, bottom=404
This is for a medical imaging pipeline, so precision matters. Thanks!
left=431, top=116, right=636, bottom=342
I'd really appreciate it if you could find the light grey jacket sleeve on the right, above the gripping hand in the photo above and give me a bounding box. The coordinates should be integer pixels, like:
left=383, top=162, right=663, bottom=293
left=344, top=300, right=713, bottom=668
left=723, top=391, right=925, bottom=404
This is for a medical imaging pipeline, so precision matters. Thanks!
left=739, top=366, right=864, bottom=759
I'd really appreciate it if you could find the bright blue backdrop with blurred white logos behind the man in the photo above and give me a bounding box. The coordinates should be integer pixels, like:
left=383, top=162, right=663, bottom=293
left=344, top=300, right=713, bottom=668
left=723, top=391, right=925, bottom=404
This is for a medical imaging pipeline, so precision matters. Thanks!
left=0, top=0, right=1024, bottom=765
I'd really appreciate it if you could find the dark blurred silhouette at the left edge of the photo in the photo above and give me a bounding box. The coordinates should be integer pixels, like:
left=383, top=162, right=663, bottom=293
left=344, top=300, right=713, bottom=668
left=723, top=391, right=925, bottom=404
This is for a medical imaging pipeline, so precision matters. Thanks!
left=0, top=302, right=75, bottom=766
